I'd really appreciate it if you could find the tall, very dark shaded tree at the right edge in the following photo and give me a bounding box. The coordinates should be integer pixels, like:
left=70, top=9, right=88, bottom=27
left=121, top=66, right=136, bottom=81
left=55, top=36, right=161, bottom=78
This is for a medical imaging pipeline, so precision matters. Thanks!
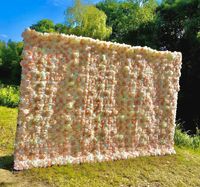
left=157, top=0, right=200, bottom=132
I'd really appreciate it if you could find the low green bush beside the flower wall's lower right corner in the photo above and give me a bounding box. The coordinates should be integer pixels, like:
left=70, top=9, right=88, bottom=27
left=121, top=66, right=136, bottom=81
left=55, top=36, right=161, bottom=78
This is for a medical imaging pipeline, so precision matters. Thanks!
left=174, top=124, right=200, bottom=149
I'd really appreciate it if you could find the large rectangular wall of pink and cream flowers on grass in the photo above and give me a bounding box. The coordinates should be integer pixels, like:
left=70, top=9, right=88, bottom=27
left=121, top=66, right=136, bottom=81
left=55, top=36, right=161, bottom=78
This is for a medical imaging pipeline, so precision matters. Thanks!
left=14, top=29, right=181, bottom=170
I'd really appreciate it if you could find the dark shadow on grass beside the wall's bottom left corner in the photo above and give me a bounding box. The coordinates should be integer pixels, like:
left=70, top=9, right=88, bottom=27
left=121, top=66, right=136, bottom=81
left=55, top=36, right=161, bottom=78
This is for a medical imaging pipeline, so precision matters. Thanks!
left=0, top=155, right=14, bottom=171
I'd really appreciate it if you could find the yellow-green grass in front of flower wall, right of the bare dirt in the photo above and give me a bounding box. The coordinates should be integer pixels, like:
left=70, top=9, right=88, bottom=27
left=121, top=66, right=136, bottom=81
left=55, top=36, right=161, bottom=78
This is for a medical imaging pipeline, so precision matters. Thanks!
left=24, top=148, right=200, bottom=187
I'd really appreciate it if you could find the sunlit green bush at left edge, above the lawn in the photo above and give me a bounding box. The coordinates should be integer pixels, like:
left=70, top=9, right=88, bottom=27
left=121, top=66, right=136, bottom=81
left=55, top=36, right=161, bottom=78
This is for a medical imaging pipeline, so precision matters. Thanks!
left=0, top=84, right=19, bottom=108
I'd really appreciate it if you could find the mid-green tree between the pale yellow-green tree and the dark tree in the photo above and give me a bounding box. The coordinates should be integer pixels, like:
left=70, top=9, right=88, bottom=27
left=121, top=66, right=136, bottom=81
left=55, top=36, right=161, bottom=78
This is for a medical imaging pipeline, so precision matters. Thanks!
left=96, top=0, right=157, bottom=44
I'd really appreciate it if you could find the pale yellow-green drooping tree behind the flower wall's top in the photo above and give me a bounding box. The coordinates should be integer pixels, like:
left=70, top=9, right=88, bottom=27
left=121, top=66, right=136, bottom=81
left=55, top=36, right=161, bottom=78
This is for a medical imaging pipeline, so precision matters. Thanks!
left=65, top=0, right=112, bottom=40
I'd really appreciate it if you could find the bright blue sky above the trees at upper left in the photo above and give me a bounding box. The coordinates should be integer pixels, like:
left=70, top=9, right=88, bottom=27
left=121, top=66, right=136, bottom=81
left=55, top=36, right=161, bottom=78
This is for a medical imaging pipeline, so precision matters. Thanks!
left=0, top=0, right=100, bottom=41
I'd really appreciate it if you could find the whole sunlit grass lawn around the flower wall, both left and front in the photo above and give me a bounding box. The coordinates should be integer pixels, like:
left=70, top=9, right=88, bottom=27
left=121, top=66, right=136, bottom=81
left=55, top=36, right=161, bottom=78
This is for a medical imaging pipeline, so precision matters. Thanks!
left=0, top=107, right=200, bottom=187
